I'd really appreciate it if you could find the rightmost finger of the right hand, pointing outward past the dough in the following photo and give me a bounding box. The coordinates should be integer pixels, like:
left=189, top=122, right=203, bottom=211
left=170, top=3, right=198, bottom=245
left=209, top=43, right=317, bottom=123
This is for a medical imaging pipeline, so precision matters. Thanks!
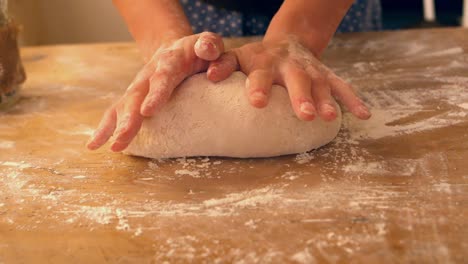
left=328, top=73, right=371, bottom=120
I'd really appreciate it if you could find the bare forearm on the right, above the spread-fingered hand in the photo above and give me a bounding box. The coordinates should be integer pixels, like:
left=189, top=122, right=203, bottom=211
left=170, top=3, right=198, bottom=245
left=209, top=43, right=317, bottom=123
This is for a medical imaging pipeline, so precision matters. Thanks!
left=265, top=0, right=354, bottom=56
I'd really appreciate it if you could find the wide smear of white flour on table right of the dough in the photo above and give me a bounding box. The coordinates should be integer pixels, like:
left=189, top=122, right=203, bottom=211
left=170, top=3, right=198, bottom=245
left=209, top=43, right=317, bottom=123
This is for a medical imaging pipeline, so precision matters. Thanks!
left=343, top=83, right=468, bottom=140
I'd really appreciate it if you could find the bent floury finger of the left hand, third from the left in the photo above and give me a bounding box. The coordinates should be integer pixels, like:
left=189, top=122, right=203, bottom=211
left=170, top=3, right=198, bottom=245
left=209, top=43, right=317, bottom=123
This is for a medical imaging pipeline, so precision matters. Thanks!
left=140, top=49, right=187, bottom=117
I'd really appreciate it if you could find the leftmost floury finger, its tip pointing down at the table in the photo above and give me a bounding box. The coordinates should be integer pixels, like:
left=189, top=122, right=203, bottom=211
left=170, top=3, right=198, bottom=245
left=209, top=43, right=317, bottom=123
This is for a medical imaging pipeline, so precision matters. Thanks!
left=86, top=107, right=117, bottom=150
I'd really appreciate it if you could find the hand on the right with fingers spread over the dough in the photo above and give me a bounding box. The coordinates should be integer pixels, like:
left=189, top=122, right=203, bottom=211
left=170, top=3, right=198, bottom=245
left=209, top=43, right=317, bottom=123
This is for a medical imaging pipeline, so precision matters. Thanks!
left=208, top=38, right=371, bottom=121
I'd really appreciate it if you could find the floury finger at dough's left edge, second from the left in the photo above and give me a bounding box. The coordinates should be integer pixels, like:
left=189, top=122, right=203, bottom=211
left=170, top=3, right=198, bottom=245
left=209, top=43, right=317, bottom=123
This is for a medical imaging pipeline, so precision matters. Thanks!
left=111, top=93, right=144, bottom=152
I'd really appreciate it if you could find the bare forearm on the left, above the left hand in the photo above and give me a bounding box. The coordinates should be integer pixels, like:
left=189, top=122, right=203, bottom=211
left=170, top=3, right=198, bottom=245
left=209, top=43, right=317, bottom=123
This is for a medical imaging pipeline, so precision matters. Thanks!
left=113, top=0, right=192, bottom=59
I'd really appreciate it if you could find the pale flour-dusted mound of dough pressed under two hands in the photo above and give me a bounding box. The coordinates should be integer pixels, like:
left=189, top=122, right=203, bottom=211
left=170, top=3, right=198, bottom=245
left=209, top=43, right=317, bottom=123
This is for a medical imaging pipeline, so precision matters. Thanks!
left=125, top=72, right=341, bottom=158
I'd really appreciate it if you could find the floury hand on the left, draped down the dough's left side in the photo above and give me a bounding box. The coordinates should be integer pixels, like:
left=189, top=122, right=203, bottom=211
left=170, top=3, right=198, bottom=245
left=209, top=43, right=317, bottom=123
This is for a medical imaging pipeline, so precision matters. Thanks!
left=87, top=32, right=235, bottom=152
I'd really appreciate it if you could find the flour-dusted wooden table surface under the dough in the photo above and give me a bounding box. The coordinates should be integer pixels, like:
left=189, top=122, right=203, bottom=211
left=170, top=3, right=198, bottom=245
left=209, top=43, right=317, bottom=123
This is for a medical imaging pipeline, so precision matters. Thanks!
left=0, top=29, right=468, bottom=263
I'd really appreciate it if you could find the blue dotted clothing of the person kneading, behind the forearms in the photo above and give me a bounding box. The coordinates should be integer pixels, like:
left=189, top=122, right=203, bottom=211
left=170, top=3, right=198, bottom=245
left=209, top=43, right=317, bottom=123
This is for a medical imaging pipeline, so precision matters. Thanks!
left=180, top=0, right=382, bottom=37
